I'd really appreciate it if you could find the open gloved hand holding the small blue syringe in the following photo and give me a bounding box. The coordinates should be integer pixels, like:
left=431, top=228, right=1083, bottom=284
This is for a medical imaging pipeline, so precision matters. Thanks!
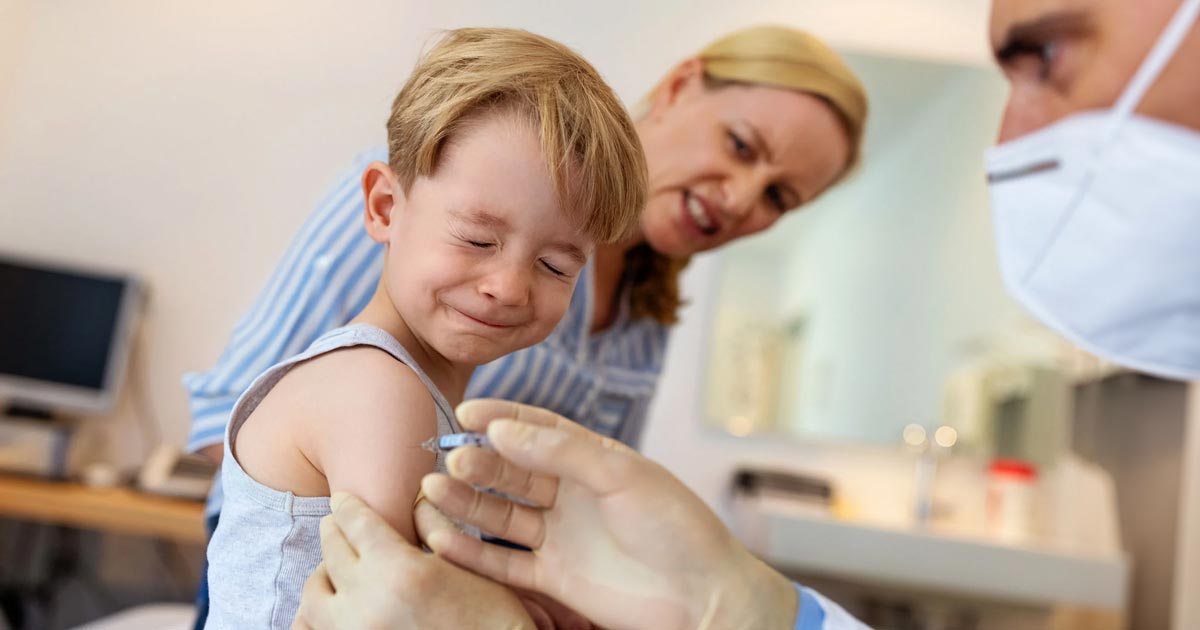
left=421, top=400, right=798, bottom=630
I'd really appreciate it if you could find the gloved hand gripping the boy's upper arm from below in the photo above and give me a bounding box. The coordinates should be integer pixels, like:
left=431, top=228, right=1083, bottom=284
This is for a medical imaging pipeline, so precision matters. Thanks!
left=292, top=493, right=535, bottom=630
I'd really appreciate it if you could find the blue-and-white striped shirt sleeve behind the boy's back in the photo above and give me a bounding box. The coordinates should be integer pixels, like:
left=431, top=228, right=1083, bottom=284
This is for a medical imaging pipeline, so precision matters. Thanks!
left=184, top=148, right=388, bottom=452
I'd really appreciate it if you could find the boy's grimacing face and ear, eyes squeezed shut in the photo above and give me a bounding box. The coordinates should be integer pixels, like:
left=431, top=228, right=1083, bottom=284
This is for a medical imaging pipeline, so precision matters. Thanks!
left=366, top=114, right=593, bottom=365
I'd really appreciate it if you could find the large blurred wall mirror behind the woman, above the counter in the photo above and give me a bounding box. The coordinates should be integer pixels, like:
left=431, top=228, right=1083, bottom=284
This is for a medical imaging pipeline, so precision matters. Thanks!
left=703, top=54, right=1084, bottom=458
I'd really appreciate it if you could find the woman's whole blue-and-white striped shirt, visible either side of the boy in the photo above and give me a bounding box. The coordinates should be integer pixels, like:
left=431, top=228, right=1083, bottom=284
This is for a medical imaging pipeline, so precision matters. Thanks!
left=184, top=148, right=668, bottom=501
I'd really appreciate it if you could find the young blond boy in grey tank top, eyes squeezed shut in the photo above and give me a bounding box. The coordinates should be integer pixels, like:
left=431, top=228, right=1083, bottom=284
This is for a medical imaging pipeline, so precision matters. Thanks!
left=208, top=29, right=646, bottom=629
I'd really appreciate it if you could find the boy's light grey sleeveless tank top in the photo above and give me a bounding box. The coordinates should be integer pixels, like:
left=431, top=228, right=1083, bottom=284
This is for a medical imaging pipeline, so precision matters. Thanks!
left=205, top=324, right=462, bottom=630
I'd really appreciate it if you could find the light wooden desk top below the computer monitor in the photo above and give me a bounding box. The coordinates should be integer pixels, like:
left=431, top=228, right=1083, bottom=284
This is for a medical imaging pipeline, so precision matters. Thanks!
left=0, top=474, right=206, bottom=545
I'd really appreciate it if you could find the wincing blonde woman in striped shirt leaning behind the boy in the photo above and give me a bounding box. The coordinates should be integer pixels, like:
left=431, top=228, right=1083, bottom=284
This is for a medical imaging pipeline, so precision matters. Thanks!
left=184, top=26, right=866, bottom=616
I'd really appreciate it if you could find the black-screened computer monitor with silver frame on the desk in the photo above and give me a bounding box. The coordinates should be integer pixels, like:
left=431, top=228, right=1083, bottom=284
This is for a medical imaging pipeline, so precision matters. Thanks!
left=0, top=256, right=142, bottom=414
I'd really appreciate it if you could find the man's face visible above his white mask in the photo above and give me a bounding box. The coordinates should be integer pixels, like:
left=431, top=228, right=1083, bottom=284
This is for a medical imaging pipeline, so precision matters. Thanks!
left=990, top=0, right=1200, bottom=142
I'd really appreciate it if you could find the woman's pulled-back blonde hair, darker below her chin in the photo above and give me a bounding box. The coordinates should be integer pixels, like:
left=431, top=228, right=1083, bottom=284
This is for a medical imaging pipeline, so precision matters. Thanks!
left=625, top=25, right=868, bottom=324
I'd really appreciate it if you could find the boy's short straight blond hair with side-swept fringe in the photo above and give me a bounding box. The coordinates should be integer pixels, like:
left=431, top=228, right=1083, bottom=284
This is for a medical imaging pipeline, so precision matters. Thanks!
left=388, top=29, right=647, bottom=244
